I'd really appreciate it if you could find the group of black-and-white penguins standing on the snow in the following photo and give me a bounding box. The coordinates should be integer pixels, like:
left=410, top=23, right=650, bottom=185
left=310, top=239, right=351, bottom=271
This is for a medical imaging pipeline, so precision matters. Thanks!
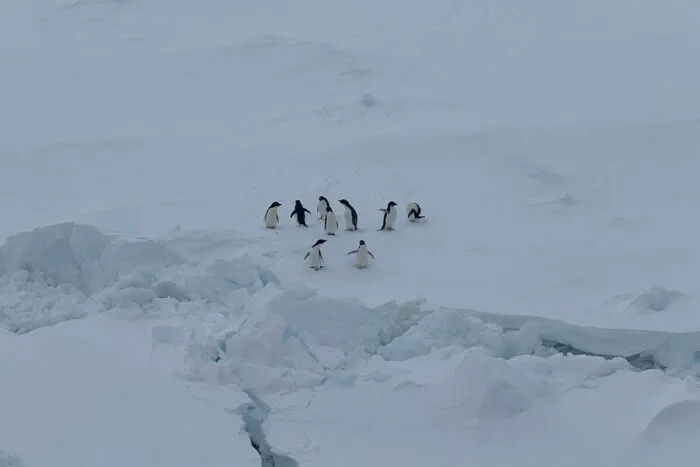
left=264, top=196, right=425, bottom=271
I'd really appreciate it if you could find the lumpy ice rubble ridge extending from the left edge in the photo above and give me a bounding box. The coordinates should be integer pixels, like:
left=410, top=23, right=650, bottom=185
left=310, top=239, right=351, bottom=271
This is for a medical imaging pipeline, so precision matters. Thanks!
left=0, top=223, right=278, bottom=333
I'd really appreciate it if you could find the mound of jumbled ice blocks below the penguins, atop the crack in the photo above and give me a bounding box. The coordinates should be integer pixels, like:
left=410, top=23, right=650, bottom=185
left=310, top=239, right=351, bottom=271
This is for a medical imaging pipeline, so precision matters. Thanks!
left=187, top=287, right=392, bottom=391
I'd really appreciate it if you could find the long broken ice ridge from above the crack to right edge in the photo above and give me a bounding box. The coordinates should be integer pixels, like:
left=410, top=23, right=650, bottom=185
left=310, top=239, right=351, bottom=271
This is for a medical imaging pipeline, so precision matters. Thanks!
left=187, top=283, right=700, bottom=394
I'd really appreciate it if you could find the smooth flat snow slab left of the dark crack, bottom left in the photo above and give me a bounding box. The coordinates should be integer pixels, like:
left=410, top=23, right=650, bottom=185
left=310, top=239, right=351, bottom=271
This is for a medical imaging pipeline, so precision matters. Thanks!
left=0, top=315, right=259, bottom=467
